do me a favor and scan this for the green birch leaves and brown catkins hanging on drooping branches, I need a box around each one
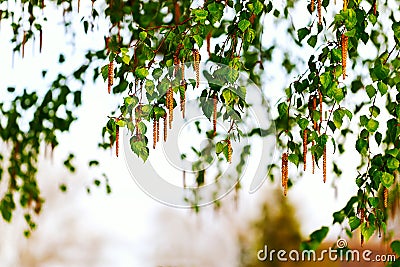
[0,0,400,254]
